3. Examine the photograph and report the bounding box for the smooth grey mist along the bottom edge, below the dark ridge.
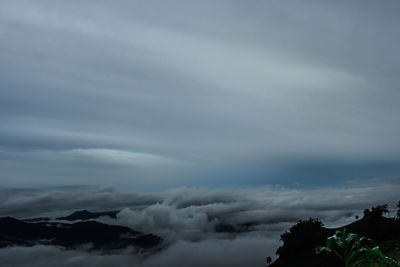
[0,240,276,267]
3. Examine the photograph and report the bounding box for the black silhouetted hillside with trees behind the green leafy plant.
[270,216,400,267]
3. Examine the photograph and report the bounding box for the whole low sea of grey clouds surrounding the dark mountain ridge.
[0,178,400,267]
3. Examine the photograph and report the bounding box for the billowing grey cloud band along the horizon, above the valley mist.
[0,178,399,224]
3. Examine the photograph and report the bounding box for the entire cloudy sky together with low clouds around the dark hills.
[0,0,400,267]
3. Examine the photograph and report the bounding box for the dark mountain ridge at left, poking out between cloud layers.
[0,217,162,251]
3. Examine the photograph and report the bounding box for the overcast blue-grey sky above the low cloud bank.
[0,0,400,191]
